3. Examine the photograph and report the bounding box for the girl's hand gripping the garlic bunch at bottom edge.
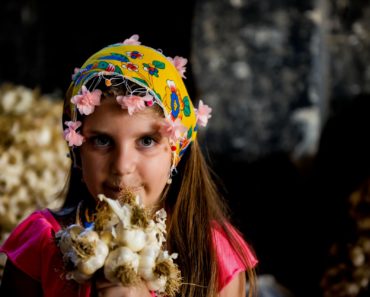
[95,279,152,297]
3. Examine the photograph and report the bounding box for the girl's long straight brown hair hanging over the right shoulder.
[165,141,256,297]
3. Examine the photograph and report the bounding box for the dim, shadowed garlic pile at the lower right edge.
[321,178,370,297]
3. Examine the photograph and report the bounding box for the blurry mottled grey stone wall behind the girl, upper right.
[192,0,370,160]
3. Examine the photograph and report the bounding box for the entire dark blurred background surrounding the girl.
[0,0,370,297]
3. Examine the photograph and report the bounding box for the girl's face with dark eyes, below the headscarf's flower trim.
[81,98,171,206]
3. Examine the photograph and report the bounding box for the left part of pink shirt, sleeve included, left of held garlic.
[0,209,90,297]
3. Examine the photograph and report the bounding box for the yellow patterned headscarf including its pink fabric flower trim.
[63,35,211,169]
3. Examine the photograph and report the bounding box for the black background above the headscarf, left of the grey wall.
[0,0,194,93]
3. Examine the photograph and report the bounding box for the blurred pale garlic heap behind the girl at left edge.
[0,84,70,279]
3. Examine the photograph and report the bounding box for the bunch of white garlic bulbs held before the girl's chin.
[56,192,181,296]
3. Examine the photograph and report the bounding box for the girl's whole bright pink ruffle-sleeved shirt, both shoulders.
[0,209,257,297]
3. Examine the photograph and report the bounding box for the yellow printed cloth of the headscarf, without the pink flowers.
[63,35,210,168]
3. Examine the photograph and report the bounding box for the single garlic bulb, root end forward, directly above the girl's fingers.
[104,247,140,286]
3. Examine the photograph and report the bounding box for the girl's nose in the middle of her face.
[111,144,137,176]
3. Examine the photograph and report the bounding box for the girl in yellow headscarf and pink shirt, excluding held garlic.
[1,35,257,297]
